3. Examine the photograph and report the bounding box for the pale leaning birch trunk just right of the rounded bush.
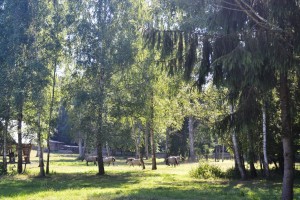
[229,104,246,180]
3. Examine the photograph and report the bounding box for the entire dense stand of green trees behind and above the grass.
[0,0,300,199]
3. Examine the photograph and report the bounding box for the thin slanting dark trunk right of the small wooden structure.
[46,60,57,174]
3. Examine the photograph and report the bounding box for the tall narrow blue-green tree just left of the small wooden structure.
[7,0,32,173]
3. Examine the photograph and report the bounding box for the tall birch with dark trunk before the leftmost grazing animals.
[68,0,136,175]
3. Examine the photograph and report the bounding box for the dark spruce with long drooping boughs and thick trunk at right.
[146,0,299,195]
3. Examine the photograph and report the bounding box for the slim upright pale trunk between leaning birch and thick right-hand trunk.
[262,102,270,178]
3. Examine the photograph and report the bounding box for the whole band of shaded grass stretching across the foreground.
[0,166,300,200]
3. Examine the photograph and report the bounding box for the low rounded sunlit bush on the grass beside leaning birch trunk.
[190,163,224,179]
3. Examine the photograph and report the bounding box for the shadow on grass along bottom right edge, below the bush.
[88,181,288,200]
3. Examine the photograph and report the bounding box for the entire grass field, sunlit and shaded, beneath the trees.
[0,151,300,200]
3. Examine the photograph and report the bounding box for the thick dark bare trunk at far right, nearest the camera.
[280,72,294,200]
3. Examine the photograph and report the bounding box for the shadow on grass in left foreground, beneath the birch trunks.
[0,172,138,199]
